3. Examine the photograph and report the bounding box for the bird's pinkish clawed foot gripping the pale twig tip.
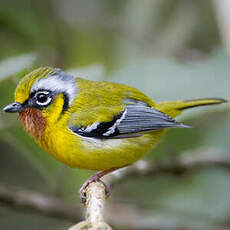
[79,175,110,203]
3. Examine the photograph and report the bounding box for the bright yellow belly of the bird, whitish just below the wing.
[39,126,164,170]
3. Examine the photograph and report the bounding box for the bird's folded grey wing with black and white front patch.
[69,102,188,139]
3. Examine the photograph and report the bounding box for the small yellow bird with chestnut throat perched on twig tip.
[3,67,226,196]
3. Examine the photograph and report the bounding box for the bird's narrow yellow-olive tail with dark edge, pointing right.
[156,98,227,118]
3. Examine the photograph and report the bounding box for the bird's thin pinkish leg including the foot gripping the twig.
[79,167,120,202]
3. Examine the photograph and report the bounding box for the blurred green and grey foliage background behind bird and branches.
[0,0,230,230]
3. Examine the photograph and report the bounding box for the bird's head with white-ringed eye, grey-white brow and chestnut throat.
[3,67,77,137]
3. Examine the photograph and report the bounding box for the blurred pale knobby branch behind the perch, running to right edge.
[104,149,230,185]
